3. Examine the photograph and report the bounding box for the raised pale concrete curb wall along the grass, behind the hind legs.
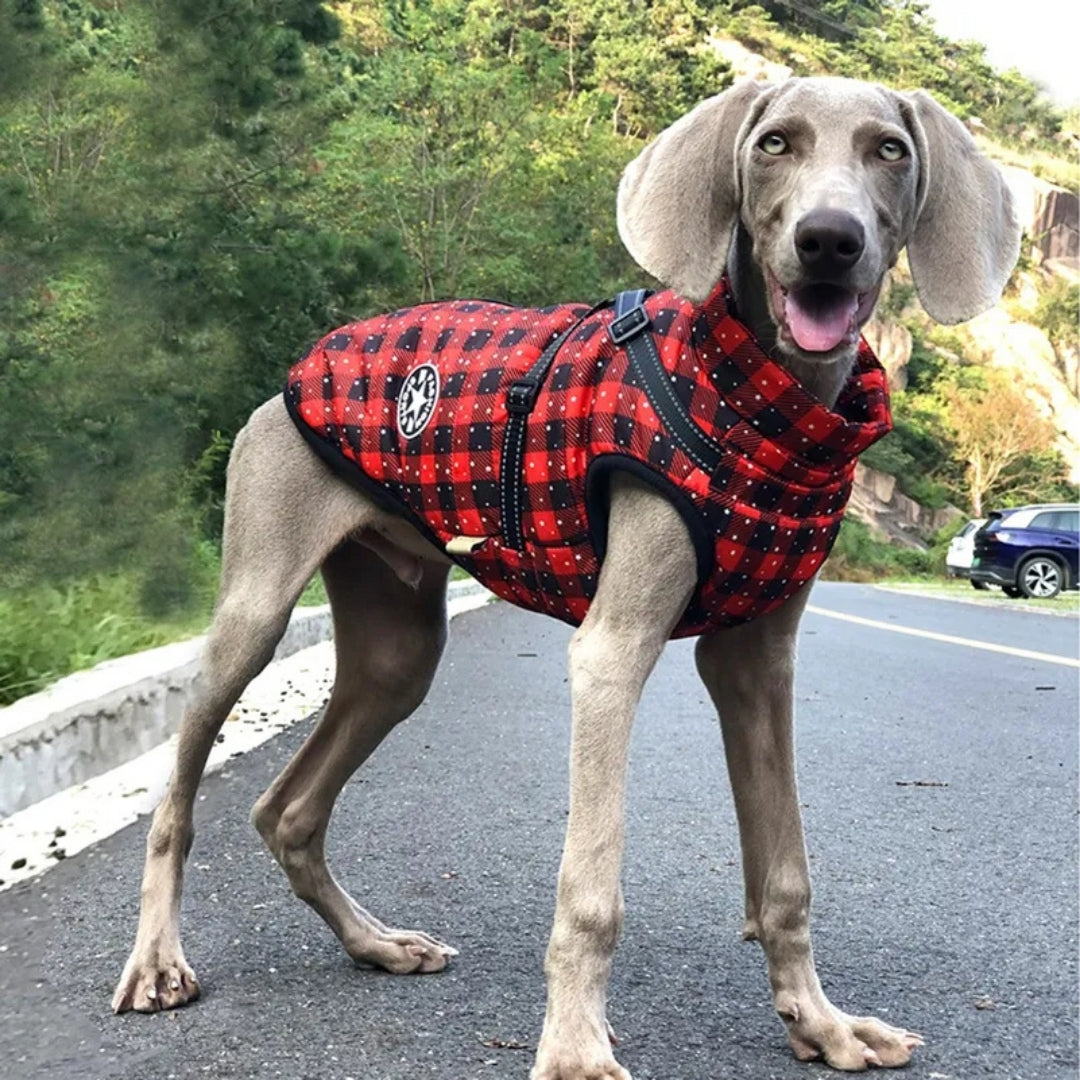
[0,581,485,818]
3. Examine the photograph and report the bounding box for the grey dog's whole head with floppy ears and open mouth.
[618,78,1020,361]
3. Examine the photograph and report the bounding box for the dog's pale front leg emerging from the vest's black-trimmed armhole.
[532,482,696,1080]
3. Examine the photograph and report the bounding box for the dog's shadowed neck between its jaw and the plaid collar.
[728,222,858,408]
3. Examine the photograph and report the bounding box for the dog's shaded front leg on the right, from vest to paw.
[697,589,922,1070]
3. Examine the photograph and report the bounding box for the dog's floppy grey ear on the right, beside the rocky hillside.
[899,90,1021,324]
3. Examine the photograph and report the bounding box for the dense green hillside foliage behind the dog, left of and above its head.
[0,0,1071,701]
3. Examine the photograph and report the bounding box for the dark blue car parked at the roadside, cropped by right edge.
[969,502,1080,598]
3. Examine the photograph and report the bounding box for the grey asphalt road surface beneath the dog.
[0,584,1078,1080]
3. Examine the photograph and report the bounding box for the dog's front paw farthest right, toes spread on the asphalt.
[777,997,922,1072]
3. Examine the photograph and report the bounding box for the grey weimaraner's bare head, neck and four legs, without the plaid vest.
[112,78,1020,1080]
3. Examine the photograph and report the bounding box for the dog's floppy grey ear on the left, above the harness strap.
[617,82,772,301]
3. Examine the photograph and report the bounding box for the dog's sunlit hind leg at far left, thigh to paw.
[112,399,379,1012]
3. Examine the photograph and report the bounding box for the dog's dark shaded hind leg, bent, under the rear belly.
[252,543,455,974]
